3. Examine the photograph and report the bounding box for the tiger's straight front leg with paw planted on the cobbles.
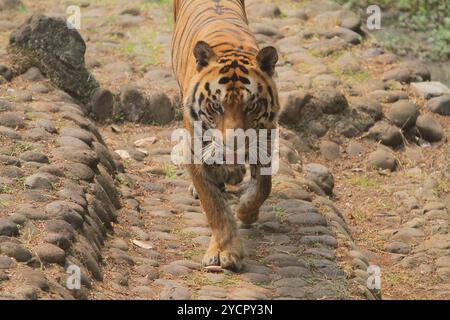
[188,165,244,271]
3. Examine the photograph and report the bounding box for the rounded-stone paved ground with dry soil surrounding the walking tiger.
[0,0,450,299]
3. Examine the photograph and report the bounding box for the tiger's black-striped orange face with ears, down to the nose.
[185,42,279,136]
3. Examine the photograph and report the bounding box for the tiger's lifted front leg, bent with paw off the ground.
[236,165,272,225]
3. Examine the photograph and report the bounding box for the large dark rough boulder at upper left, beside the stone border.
[8,14,99,104]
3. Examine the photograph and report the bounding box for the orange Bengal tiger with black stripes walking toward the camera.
[172,0,279,271]
